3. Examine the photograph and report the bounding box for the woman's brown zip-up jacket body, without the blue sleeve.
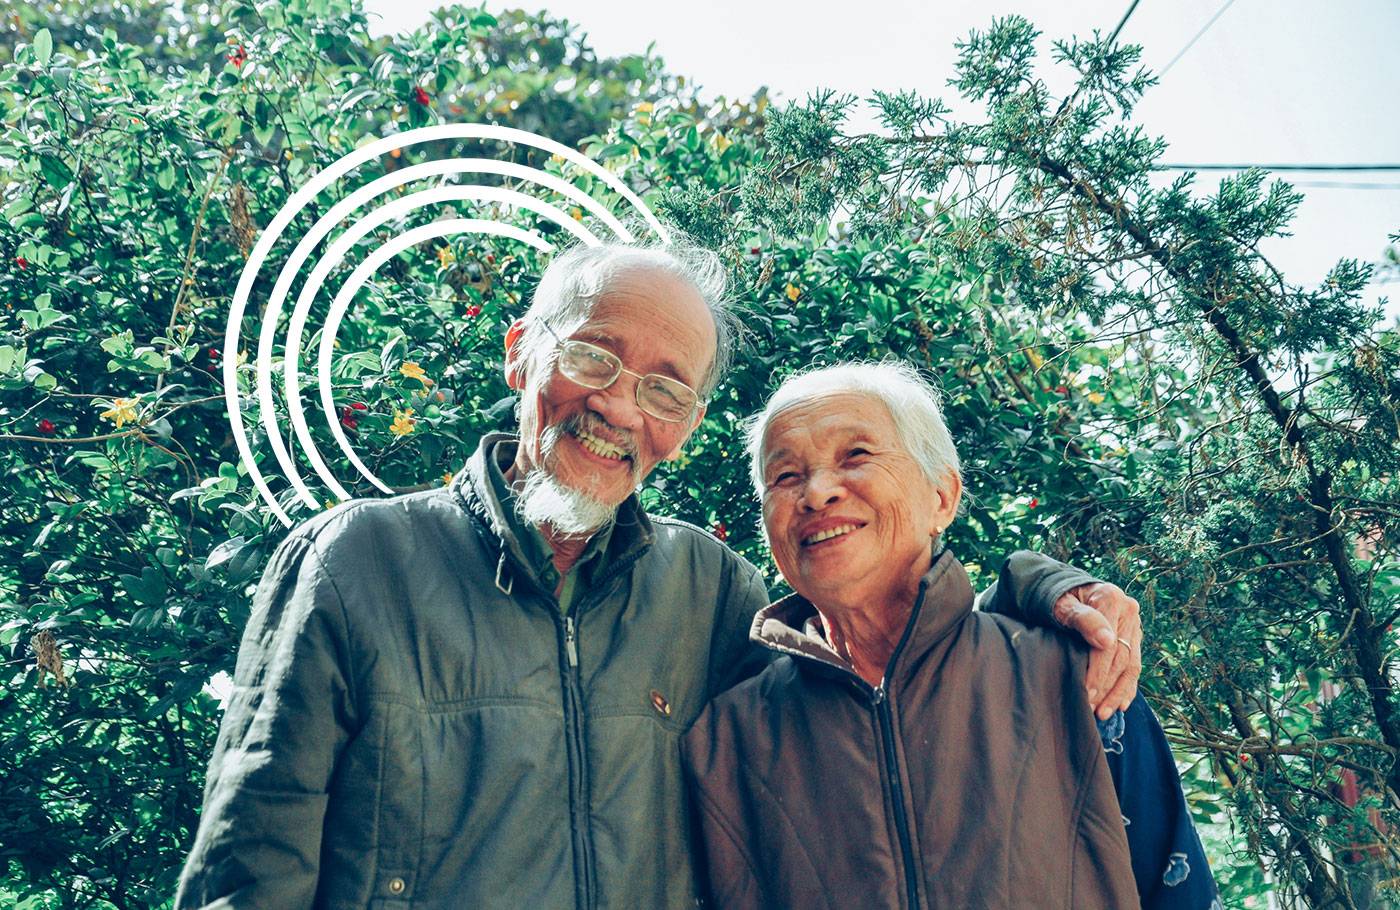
[685,552,1138,910]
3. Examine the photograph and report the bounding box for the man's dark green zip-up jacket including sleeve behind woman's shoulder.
[176,434,1089,910]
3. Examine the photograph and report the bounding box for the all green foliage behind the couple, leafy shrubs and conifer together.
[0,0,1400,907]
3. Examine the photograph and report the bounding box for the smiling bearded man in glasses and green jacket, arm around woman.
[176,238,1138,910]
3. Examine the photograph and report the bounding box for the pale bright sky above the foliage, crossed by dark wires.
[365,0,1400,315]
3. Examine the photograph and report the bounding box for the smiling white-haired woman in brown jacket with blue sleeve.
[685,364,1215,910]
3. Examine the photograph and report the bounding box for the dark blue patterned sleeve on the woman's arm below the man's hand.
[1099,694,1221,910]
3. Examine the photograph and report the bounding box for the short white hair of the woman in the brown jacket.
[745,360,962,498]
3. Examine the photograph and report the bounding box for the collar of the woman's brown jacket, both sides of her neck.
[749,550,973,685]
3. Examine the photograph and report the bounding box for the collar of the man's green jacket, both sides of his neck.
[452,433,655,584]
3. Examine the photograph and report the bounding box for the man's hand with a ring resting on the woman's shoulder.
[1054,581,1142,720]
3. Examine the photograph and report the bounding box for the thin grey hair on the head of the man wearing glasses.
[519,239,738,400]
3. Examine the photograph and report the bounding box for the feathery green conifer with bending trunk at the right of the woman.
[716,18,1400,907]
